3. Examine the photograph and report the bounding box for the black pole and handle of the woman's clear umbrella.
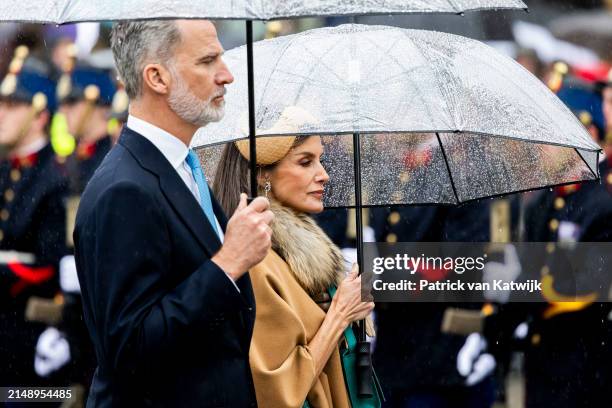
[353,133,373,397]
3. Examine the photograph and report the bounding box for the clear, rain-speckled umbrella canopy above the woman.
[193,25,600,207]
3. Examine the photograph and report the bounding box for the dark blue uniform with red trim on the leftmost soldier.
[0,144,68,385]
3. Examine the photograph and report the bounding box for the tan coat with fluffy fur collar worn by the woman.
[249,204,350,408]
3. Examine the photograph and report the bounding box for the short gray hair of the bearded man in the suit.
[111,20,181,99]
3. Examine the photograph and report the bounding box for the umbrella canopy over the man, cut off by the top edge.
[0,0,527,24]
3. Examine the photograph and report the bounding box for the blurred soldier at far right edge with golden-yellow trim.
[525,75,612,407]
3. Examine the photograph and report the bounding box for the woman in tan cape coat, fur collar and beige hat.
[214,111,374,408]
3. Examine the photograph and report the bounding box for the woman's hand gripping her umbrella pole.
[330,264,374,327]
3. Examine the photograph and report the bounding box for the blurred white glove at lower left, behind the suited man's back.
[34,327,70,377]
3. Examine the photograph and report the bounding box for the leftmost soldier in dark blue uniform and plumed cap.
[0,46,68,386]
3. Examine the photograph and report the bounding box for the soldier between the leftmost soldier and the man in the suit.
[32,67,121,400]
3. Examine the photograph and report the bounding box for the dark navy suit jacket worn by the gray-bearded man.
[74,128,256,408]
